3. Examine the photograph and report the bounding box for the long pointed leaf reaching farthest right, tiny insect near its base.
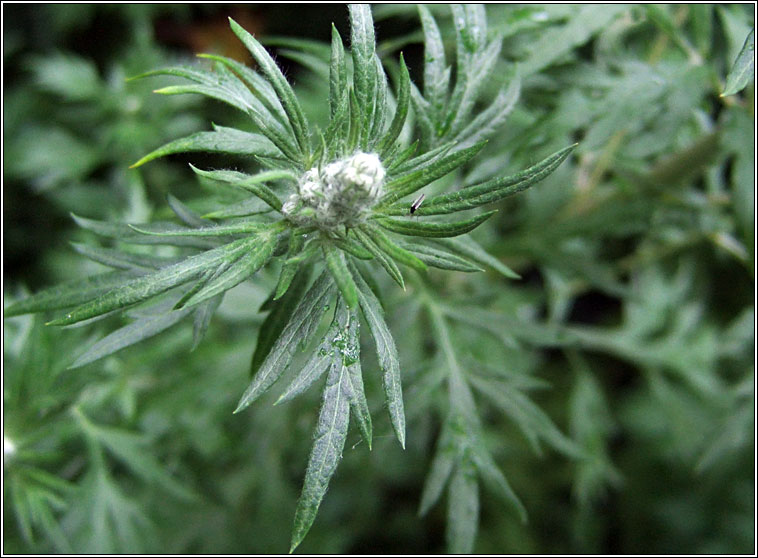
[394,144,577,215]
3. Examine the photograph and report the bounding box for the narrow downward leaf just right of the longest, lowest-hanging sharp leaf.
[353,268,405,448]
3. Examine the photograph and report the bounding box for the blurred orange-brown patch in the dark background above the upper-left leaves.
[155,6,266,63]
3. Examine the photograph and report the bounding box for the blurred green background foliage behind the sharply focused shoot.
[3,4,755,554]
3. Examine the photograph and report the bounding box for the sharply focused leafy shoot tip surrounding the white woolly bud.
[6,5,574,549]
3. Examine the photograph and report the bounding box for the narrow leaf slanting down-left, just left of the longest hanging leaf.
[234,271,334,413]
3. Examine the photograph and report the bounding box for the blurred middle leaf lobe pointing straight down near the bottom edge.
[445,458,479,554]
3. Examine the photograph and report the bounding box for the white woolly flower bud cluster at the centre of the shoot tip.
[282,152,385,229]
